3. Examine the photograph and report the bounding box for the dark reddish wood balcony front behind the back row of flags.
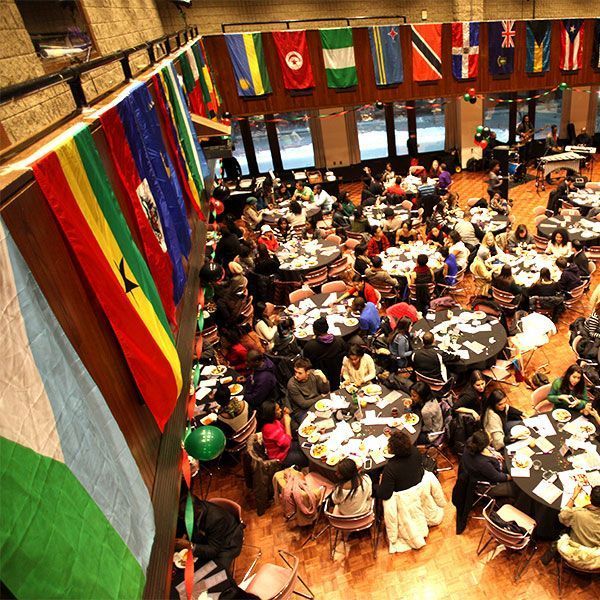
[204,19,600,116]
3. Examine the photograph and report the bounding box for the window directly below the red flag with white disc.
[275,112,315,169]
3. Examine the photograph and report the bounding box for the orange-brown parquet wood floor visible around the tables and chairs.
[204,164,600,600]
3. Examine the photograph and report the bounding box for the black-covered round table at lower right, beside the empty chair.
[504,411,600,539]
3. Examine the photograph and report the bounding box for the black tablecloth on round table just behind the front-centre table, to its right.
[412,310,508,371]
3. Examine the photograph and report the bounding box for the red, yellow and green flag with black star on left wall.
[33,125,182,431]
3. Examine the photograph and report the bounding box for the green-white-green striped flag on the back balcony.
[320,27,358,89]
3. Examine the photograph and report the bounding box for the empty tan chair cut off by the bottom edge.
[240,550,315,600]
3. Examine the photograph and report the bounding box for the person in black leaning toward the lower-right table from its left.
[460,431,518,498]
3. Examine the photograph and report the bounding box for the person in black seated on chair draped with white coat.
[373,429,425,500]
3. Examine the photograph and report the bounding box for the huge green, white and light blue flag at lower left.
[0,220,155,598]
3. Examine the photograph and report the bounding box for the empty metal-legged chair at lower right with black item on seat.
[477,500,537,582]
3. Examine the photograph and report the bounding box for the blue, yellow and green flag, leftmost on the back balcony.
[225,33,271,96]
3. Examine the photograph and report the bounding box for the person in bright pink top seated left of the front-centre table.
[261,402,308,467]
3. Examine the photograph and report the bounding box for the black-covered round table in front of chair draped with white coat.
[298,384,421,478]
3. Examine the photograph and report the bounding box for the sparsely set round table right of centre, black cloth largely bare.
[412,310,508,371]
